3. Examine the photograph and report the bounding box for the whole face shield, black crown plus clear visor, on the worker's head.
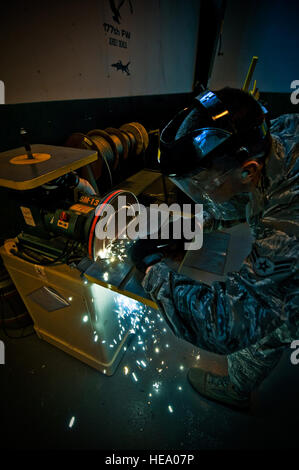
[160,91,267,218]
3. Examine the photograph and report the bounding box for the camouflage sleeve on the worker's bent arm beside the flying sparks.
[143,233,299,354]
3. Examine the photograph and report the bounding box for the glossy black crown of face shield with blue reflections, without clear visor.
[159,90,269,176]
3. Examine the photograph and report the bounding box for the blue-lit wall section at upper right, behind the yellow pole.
[209,0,299,92]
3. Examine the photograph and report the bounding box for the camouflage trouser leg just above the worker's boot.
[227,321,299,393]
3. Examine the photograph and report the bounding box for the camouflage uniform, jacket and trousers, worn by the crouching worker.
[143,114,299,392]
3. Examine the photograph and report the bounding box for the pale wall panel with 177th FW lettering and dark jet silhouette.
[0,0,200,104]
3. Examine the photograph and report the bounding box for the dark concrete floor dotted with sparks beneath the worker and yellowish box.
[0,226,299,450]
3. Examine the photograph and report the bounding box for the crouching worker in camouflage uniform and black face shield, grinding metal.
[130,88,299,408]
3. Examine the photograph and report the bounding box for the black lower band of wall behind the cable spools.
[0,93,191,152]
